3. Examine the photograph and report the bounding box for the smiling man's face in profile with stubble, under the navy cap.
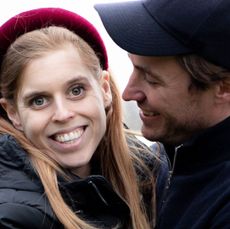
[123,54,217,144]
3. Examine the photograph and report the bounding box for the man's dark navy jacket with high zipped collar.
[157,117,230,229]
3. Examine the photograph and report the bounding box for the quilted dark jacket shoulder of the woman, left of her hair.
[0,135,61,229]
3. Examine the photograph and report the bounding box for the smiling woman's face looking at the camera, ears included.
[3,47,111,176]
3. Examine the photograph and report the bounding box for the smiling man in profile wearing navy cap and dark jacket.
[95,0,230,229]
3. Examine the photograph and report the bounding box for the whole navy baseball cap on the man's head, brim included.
[95,0,230,69]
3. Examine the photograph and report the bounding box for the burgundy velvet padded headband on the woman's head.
[0,8,108,69]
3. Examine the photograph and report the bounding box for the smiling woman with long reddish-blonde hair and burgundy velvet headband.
[0,8,164,229]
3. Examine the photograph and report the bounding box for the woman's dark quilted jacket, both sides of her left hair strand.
[0,135,164,229]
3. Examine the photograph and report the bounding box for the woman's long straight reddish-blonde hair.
[0,26,157,229]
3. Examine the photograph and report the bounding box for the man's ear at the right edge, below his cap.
[215,79,230,103]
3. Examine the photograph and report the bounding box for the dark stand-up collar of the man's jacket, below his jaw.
[165,117,230,172]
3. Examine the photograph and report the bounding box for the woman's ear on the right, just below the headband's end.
[101,70,112,108]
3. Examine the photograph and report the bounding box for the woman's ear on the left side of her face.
[0,98,23,131]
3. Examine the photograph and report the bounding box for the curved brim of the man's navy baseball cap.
[94,1,192,56]
